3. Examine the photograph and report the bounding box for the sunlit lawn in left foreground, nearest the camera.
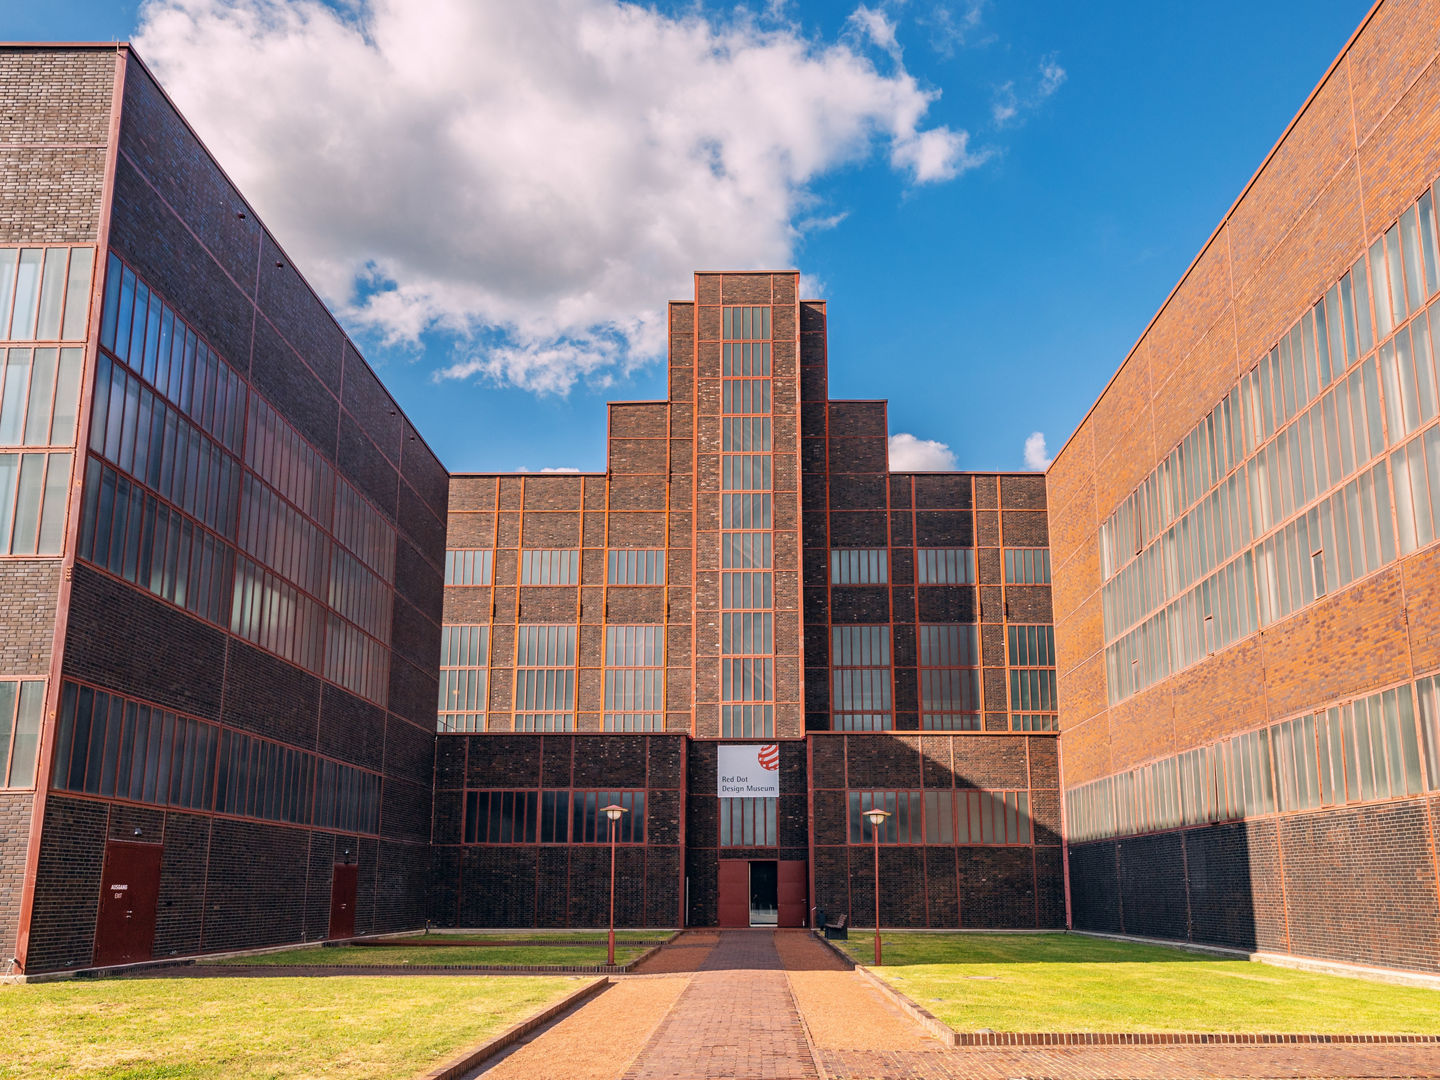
[0,975,588,1080]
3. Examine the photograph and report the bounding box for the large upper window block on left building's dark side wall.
[81,253,396,704]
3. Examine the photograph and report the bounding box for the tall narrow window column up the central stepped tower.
[720,307,775,739]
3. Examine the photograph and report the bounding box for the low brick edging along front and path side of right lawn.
[815,935,1440,1047]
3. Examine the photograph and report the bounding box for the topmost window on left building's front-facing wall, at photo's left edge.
[0,248,95,341]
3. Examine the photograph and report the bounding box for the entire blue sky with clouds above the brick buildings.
[16,0,1368,471]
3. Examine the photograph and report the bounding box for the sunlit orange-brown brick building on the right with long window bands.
[1047,0,1440,972]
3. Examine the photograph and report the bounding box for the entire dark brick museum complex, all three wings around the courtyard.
[8,0,1440,990]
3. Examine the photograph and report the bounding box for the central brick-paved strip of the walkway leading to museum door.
[625,930,819,1080]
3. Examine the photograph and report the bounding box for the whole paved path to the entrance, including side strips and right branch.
[484,930,1440,1080]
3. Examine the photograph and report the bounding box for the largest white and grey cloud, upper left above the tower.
[135,0,985,393]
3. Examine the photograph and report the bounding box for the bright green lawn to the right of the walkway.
[841,930,1440,1034]
